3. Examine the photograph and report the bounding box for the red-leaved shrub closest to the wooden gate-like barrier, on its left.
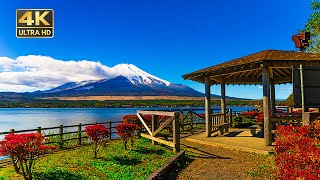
[116,124,140,149]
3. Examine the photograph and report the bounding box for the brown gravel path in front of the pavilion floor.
[177,139,274,180]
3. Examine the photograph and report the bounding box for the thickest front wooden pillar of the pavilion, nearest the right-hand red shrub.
[262,65,271,146]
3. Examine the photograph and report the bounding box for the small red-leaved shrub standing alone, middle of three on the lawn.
[85,124,110,158]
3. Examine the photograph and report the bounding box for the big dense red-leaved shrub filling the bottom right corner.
[275,126,320,179]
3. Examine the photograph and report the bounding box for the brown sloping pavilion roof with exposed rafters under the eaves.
[182,50,320,84]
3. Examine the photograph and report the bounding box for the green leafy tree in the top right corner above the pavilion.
[300,0,320,53]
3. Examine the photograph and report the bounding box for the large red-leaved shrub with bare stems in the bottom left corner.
[0,133,55,179]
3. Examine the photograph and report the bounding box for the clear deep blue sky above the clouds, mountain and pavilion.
[0,0,311,98]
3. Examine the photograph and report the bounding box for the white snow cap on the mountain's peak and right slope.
[110,64,171,86]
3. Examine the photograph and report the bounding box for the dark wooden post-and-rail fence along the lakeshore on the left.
[0,121,122,149]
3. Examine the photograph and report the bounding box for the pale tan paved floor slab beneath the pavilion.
[185,129,274,154]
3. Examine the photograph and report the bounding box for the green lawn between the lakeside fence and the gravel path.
[0,138,174,180]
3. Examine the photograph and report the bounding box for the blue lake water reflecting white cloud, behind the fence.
[0,107,254,160]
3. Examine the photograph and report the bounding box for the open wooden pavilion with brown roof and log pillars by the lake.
[182,50,320,146]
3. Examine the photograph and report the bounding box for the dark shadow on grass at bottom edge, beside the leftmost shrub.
[35,169,85,180]
